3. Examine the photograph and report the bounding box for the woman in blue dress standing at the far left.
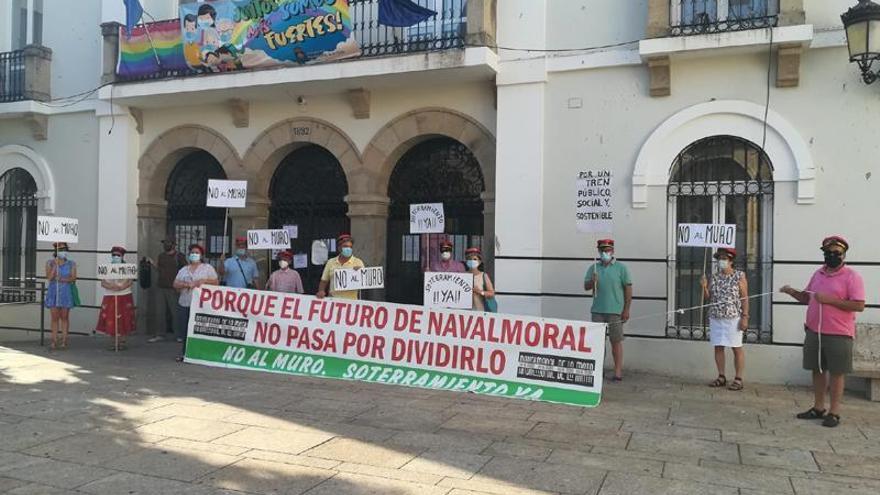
[46,242,76,350]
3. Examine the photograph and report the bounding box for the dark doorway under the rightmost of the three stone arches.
[385,137,486,304]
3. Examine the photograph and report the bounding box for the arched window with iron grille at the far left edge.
[0,168,38,302]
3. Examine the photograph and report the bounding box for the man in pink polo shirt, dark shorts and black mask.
[780,235,865,428]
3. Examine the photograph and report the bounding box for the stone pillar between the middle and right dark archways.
[345,194,391,300]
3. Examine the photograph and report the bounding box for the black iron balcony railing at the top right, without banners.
[669,0,779,36]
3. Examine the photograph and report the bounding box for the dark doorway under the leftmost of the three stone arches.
[165,150,232,268]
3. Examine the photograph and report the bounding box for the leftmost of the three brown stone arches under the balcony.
[138,124,244,205]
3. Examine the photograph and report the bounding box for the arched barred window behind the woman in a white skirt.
[667,136,774,343]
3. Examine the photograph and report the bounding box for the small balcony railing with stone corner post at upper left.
[0,45,52,103]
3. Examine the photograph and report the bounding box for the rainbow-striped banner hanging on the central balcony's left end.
[116,19,190,79]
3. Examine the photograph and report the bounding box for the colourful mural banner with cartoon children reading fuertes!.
[180,0,361,72]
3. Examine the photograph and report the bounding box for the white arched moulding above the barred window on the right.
[632,100,816,208]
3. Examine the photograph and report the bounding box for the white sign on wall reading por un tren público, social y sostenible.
[575,170,614,233]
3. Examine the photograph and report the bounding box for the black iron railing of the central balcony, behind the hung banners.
[116,0,468,81]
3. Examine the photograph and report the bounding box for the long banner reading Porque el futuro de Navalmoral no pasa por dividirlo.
[186,286,605,406]
